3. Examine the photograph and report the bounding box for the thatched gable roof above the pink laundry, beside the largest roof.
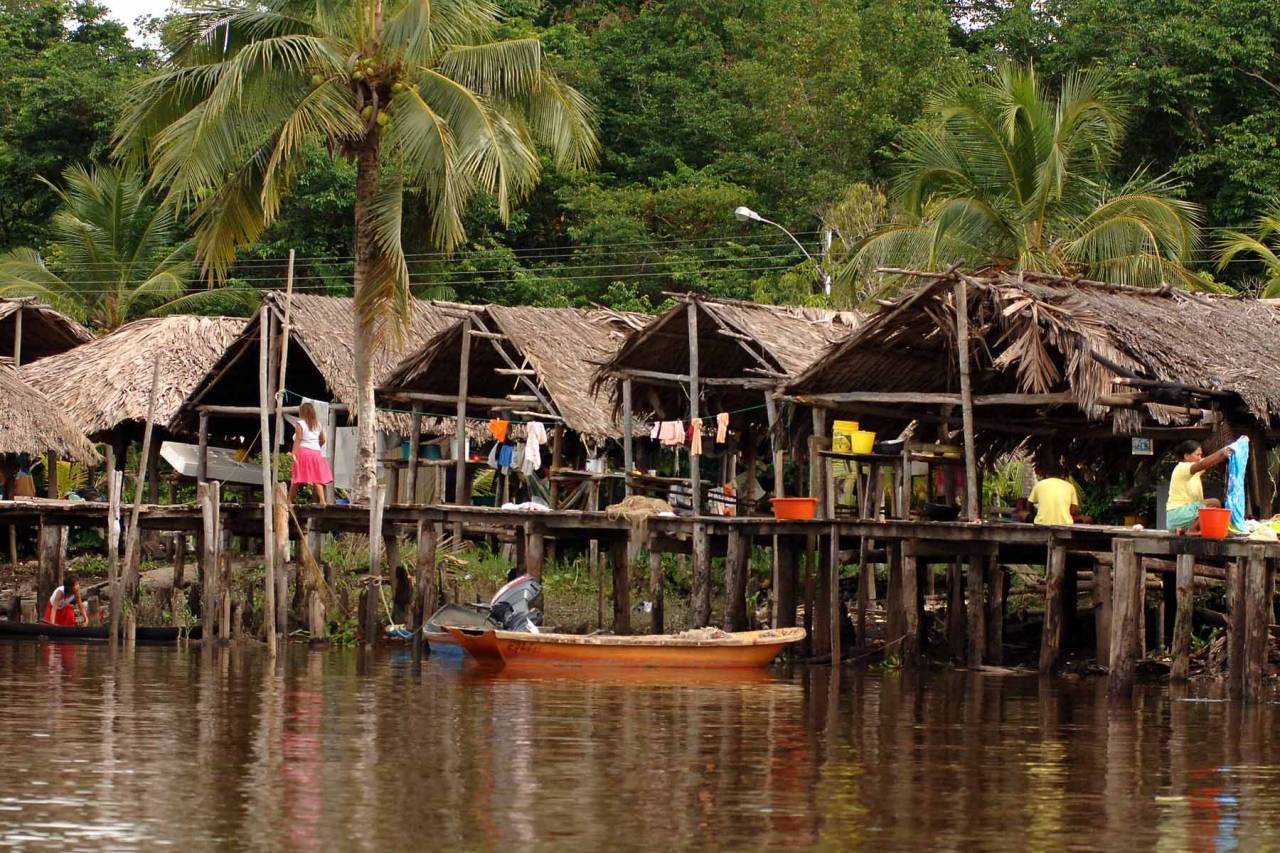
[598,293,861,418]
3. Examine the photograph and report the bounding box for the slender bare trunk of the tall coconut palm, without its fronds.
[352,132,379,503]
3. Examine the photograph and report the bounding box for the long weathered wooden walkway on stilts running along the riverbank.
[0,500,1280,701]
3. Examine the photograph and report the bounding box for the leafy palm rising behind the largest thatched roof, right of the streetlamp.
[842,65,1204,297]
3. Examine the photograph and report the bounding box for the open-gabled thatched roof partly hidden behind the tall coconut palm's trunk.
[177,292,461,434]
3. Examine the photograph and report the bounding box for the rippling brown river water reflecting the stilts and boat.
[0,642,1280,852]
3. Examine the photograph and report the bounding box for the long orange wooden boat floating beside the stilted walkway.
[447,626,804,670]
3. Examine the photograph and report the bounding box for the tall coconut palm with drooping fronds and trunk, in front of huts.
[116,0,596,498]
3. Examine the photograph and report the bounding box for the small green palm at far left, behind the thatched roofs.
[0,165,217,329]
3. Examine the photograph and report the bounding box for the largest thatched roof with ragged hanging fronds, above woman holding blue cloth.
[788,273,1280,433]
